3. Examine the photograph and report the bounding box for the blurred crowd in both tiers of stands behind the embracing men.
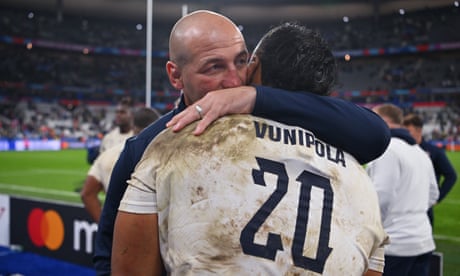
[0,5,460,140]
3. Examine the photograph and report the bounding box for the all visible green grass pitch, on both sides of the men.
[0,150,460,276]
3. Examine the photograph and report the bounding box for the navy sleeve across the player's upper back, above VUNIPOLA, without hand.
[253,86,391,164]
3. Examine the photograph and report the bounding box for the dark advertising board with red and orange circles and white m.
[10,197,97,267]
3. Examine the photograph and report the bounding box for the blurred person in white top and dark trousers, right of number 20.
[367,104,439,276]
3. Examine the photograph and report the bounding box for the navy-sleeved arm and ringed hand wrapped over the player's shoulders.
[167,86,391,164]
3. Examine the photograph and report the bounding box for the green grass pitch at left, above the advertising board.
[0,150,89,203]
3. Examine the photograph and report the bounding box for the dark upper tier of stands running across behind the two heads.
[0,4,460,50]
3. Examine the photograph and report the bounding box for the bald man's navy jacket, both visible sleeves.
[93,86,390,275]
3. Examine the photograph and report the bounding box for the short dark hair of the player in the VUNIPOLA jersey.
[256,22,337,95]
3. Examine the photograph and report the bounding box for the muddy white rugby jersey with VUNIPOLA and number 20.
[119,115,386,275]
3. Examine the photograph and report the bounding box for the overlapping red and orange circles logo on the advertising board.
[27,208,64,250]
